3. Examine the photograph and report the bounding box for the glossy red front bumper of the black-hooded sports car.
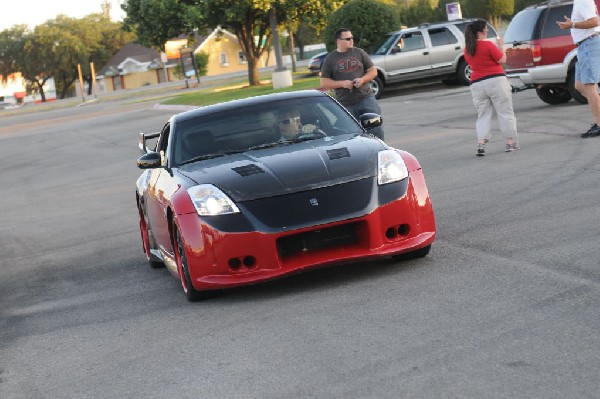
[178,170,436,290]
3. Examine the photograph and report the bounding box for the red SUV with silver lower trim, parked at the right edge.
[504,0,600,104]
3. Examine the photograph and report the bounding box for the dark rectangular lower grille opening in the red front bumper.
[277,223,359,258]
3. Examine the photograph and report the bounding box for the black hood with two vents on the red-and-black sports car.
[179,136,385,201]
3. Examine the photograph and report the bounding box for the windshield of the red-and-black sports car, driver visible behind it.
[172,96,364,165]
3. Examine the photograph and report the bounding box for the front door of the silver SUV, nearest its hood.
[385,31,431,83]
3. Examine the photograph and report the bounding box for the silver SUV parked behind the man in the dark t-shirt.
[370,18,498,98]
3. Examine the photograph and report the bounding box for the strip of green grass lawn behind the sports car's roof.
[162,72,320,106]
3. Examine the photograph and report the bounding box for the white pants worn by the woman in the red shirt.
[470,76,519,145]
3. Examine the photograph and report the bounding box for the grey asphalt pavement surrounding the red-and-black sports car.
[0,85,600,399]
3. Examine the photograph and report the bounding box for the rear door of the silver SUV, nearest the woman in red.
[427,27,463,76]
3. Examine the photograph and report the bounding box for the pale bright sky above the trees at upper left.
[0,0,125,31]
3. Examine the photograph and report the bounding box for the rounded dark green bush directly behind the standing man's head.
[325,0,400,51]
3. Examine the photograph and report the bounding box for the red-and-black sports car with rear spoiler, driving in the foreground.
[136,90,436,301]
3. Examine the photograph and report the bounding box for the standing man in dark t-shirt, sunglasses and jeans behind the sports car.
[321,28,383,140]
